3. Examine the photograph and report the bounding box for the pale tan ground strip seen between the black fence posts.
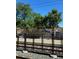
[16,38,63,45]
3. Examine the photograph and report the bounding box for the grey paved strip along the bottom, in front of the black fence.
[16,51,63,59]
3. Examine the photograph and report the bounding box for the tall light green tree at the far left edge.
[16,3,32,28]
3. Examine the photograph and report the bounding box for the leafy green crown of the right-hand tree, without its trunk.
[48,9,62,29]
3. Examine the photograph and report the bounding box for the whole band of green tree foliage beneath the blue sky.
[16,3,62,29]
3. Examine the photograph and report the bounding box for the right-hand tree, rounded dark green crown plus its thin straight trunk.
[47,9,62,52]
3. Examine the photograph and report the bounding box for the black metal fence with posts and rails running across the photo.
[16,32,63,57]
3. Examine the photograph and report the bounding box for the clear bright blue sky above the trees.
[16,0,63,27]
